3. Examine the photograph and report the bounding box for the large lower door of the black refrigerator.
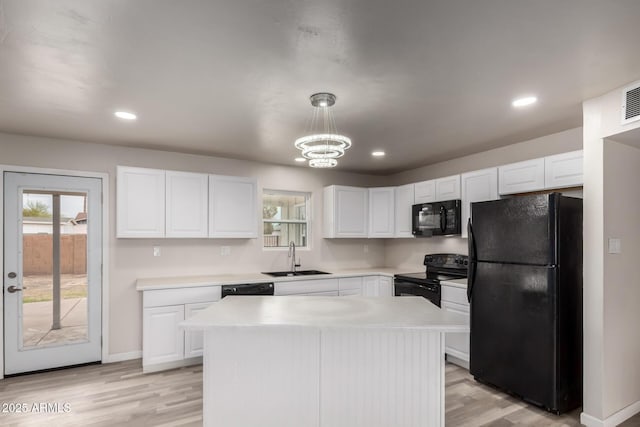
[470,262,557,410]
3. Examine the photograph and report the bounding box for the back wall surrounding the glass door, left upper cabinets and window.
[0,134,385,354]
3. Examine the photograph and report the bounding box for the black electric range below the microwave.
[393,254,469,307]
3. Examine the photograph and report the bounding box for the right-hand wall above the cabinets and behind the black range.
[384,128,582,272]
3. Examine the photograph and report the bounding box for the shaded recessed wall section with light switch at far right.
[603,139,640,416]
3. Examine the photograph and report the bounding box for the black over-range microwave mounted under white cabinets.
[412,200,462,237]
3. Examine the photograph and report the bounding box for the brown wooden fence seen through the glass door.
[22,234,87,276]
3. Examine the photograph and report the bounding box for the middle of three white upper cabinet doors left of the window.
[165,171,209,237]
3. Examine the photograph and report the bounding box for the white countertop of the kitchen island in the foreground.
[181,295,469,332]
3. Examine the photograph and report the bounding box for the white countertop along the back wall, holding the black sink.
[136,267,400,291]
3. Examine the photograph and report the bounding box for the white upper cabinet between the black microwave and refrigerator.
[460,168,499,237]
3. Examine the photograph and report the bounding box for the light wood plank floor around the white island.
[0,360,640,427]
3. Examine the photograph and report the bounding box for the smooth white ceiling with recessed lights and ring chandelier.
[0,0,640,174]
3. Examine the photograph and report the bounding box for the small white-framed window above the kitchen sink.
[262,190,311,248]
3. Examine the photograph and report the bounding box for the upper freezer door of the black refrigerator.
[470,194,559,265]
